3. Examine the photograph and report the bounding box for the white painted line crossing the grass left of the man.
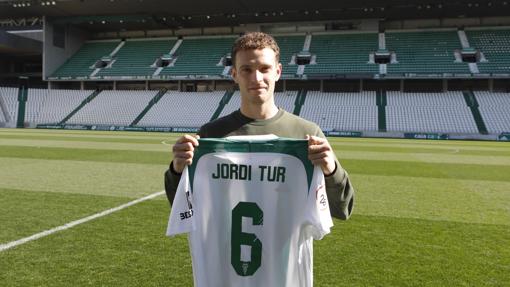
[0,190,165,252]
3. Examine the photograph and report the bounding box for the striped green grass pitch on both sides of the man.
[0,129,510,287]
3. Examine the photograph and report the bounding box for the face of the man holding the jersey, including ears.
[232,48,282,104]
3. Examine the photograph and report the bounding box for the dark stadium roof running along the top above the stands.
[0,0,510,31]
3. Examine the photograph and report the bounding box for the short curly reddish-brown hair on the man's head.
[231,32,280,67]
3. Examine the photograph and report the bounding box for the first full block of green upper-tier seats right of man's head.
[305,33,379,75]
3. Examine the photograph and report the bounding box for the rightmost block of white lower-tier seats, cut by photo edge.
[474,91,510,133]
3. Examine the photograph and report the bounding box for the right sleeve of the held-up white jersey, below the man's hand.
[306,167,333,240]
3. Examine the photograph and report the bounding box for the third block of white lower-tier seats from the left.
[67,91,158,126]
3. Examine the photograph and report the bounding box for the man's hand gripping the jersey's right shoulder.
[306,135,336,176]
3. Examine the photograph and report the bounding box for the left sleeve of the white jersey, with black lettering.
[166,167,195,236]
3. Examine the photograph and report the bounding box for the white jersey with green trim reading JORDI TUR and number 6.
[167,137,333,287]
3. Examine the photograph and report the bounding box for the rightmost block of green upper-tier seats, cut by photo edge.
[466,29,510,74]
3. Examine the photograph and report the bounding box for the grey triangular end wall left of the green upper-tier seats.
[43,17,90,79]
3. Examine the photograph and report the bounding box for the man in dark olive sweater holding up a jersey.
[165,32,354,220]
